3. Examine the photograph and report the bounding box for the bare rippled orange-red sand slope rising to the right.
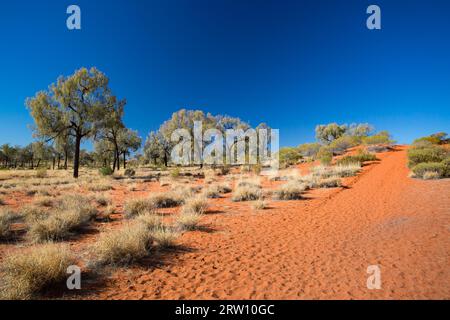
[89,148,450,299]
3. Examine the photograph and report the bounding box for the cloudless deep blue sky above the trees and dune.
[0,0,450,145]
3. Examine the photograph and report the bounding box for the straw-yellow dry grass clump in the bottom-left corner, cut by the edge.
[1,244,75,299]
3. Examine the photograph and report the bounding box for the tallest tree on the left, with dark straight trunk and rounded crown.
[26,68,114,178]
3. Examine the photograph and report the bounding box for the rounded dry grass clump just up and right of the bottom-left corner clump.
[92,223,153,265]
